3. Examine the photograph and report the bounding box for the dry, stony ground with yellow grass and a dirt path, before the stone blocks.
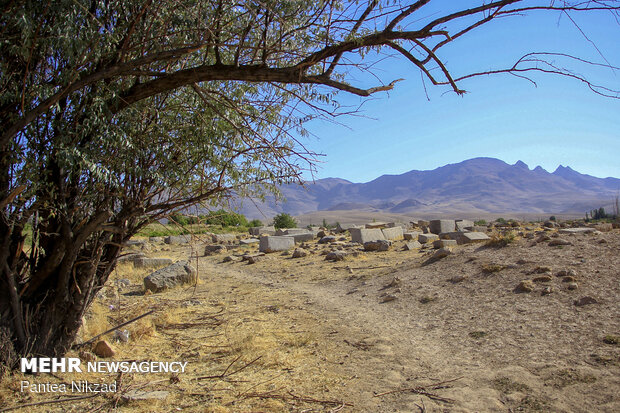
[0,220,620,412]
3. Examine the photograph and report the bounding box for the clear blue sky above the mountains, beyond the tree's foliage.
[304,2,620,182]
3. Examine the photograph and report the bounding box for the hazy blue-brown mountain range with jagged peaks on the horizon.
[234,158,620,218]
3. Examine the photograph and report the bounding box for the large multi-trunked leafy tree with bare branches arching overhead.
[0,0,619,364]
